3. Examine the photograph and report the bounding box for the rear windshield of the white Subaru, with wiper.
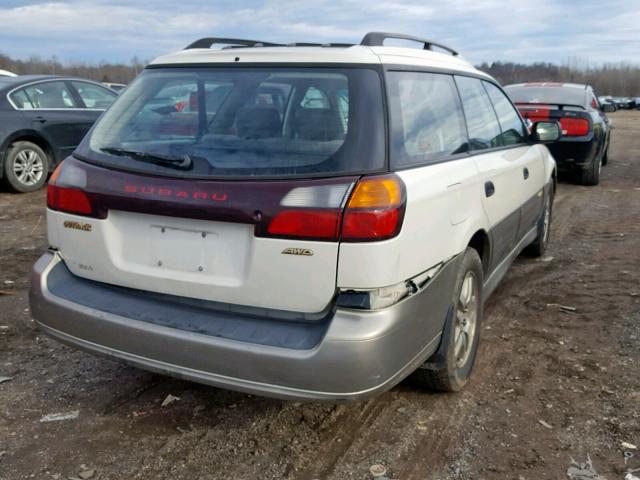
[77,67,385,178]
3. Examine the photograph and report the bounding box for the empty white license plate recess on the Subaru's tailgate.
[150,225,218,275]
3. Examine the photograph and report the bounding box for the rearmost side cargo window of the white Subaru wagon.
[387,72,467,166]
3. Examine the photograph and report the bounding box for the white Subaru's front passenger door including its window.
[482,82,545,241]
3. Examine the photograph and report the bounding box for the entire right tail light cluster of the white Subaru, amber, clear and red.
[266,175,405,242]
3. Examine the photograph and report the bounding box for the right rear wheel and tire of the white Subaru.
[411,247,484,392]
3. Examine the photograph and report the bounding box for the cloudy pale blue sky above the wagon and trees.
[0,0,640,66]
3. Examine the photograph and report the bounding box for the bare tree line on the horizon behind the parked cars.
[0,53,640,96]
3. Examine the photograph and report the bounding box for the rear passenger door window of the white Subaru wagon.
[456,76,502,150]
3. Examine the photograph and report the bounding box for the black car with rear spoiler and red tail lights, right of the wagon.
[505,82,613,185]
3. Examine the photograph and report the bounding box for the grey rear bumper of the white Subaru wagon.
[30,252,457,400]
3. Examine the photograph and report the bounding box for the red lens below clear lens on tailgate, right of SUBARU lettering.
[268,209,340,240]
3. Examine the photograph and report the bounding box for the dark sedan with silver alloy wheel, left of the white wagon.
[0,75,117,192]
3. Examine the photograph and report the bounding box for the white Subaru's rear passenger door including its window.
[456,76,525,268]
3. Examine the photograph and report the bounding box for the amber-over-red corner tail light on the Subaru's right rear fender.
[341,175,405,242]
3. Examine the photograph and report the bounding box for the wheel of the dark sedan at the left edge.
[4,142,49,193]
